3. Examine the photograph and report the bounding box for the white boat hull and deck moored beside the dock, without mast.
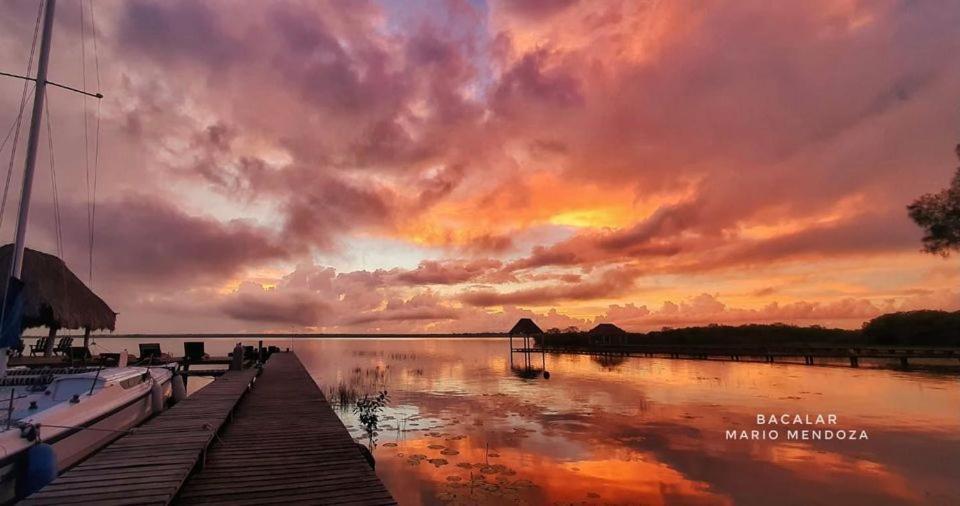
[0,367,173,504]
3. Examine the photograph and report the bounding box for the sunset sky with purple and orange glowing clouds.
[0,0,960,332]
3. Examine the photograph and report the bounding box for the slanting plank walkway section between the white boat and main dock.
[20,369,258,505]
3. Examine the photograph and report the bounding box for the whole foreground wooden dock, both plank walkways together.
[21,353,396,505]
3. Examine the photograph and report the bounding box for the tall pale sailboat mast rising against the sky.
[10,0,57,279]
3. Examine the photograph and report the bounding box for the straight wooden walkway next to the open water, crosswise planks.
[176,353,396,505]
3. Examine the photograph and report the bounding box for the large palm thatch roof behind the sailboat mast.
[0,244,117,330]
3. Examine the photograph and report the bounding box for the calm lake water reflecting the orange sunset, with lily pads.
[92,339,960,505]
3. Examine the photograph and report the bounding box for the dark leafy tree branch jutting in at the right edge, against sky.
[907,144,960,256]
